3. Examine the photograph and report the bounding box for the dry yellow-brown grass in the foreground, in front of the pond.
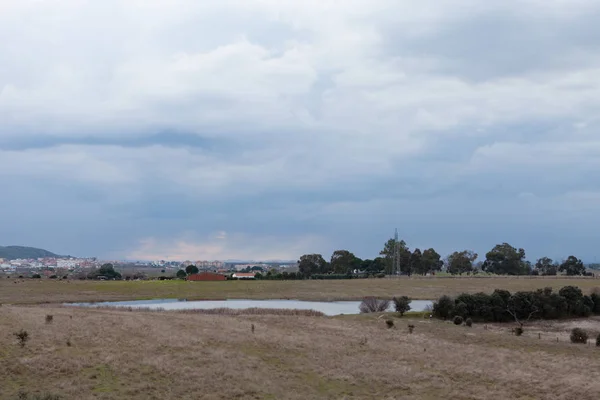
[0,306,600,400]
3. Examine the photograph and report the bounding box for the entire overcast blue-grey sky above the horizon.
[0,0,600,262]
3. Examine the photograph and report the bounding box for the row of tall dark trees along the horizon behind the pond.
[298,239,586,278]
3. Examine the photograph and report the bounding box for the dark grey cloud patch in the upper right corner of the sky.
[385,4,600,82]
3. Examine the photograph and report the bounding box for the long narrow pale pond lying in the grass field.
[68,299,433,316]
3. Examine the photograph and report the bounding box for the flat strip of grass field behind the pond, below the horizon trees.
[0,277,600,304]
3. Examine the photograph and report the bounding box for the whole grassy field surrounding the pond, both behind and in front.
[0,278,600,400]
